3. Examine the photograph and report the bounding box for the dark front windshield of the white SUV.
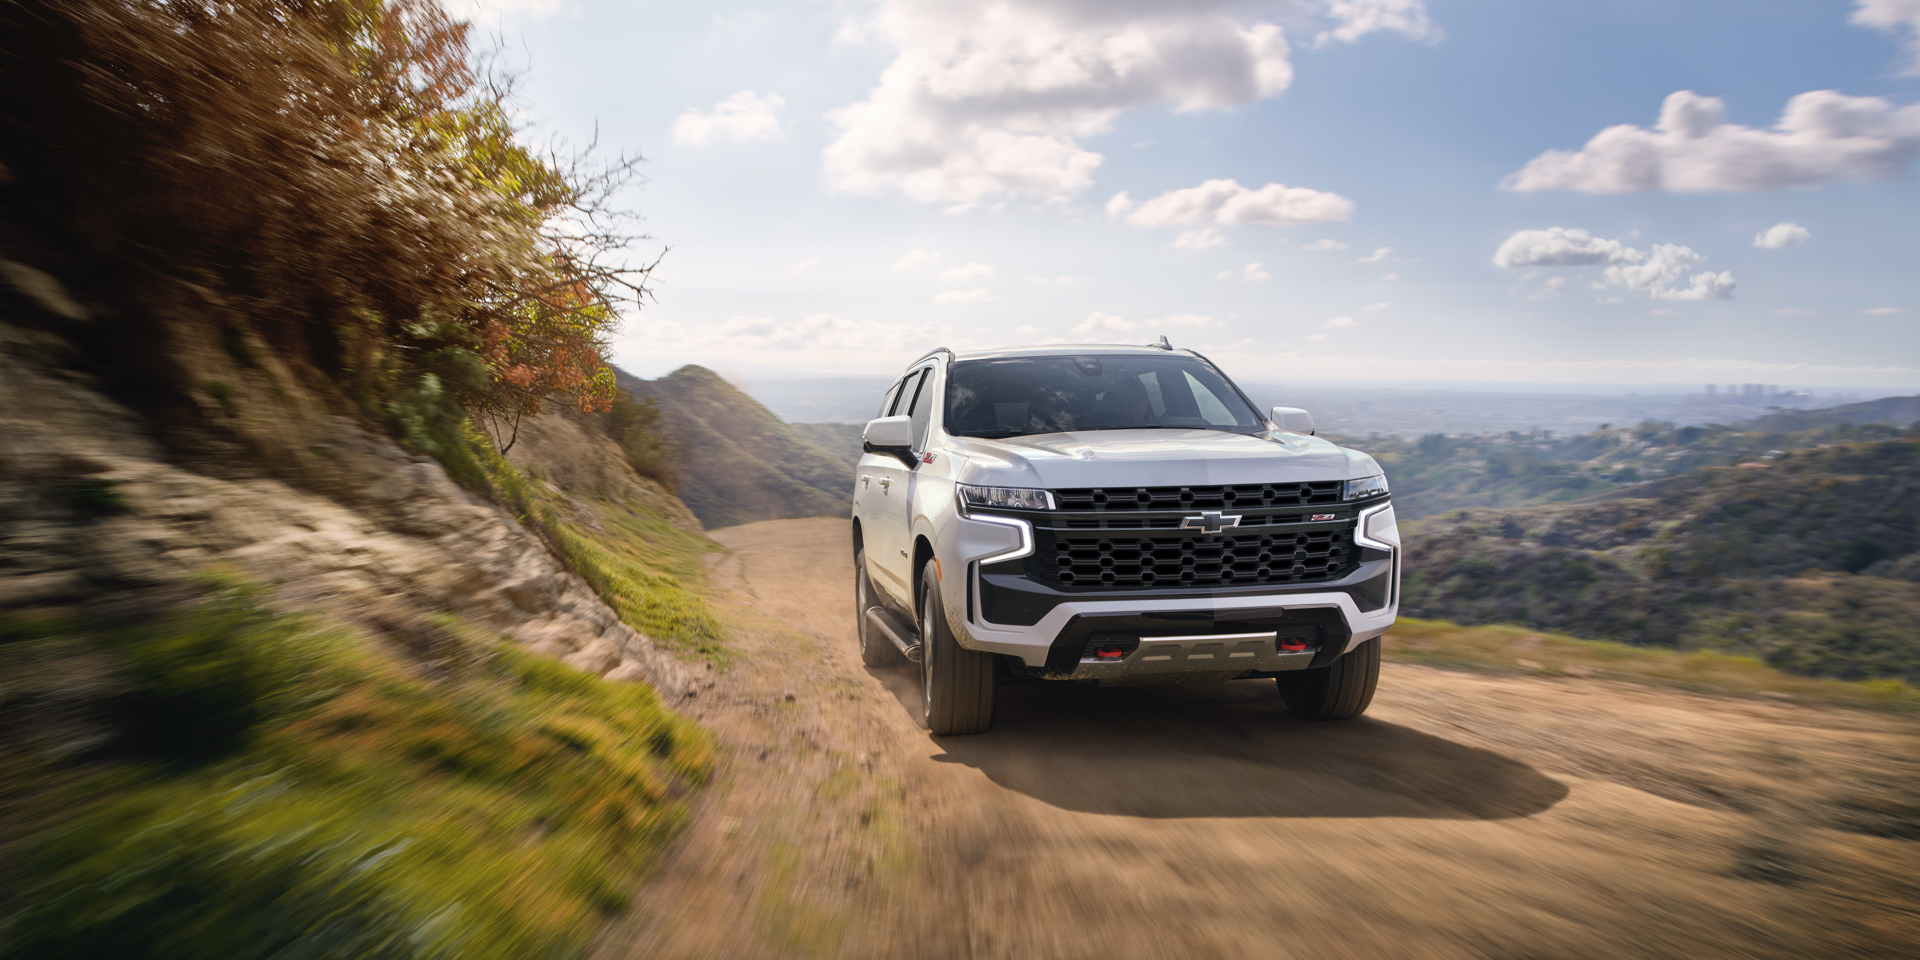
[947,355,1267,438]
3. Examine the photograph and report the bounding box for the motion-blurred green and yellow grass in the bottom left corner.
[0,584,712,960]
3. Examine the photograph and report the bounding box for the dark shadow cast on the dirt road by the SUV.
[874,668,1569,820]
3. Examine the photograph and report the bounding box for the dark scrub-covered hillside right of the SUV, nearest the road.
[1404,442,1920,678]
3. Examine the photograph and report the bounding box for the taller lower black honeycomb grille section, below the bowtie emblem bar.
[1029,528,1356,589]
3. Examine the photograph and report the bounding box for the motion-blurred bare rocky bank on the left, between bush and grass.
[0,261,697,697]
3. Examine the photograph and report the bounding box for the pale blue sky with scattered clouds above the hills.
[447,0,1920,392]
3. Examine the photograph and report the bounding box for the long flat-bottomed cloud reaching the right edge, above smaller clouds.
[1501,90,1920,194]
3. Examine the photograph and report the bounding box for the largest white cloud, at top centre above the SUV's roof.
[826,0,1294,204]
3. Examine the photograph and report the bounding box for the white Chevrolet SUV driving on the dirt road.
[852,338,1400,733]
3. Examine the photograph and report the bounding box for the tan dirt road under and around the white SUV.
[599,520,1920,960]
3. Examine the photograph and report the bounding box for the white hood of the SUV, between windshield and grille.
[950,430,1380,488]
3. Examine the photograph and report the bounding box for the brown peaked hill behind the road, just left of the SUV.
[614,365,852,530]
